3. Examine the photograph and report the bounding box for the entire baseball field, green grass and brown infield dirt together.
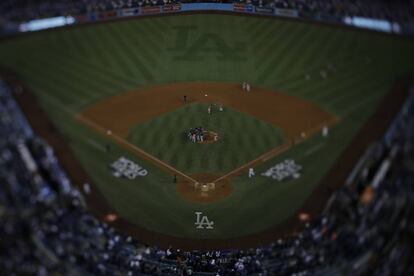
[0,14,414,248]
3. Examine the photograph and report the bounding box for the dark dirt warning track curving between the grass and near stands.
[3,69,413,250]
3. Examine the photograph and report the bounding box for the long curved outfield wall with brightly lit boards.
[4,3,414,36]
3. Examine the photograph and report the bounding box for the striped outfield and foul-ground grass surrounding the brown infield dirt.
[0,14,414,238]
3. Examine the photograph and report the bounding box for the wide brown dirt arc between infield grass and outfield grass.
[81,82,334,139]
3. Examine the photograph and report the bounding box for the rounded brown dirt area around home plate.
[177,173,232,203]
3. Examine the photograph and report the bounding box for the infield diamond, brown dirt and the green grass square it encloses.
[78,83,338,202]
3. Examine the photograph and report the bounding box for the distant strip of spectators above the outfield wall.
[0,0,414,22]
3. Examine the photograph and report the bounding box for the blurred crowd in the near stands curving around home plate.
[0,76,414,275]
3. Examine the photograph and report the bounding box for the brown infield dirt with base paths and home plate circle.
[78,82,338,203]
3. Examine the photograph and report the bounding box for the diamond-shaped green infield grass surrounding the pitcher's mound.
[128,103,283,173]
